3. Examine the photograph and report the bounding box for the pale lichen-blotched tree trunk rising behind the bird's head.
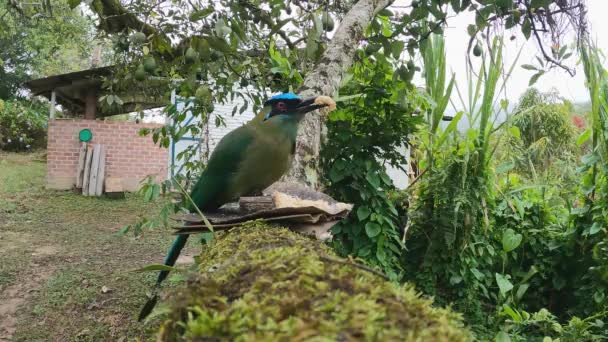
[284,0,393,188]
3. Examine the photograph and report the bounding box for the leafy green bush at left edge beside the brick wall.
[0,100,47,151]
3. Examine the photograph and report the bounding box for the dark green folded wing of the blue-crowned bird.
[189,125,255,211]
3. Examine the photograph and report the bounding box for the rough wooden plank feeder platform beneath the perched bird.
[173,182,353,240]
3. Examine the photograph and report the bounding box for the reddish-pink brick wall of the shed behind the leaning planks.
[47,119,168,191]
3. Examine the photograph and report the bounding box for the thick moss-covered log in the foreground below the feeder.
[159,223,470,341]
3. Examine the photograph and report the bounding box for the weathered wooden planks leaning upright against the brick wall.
[76,143,106,196]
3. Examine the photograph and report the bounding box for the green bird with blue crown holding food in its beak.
[139,93,336,320]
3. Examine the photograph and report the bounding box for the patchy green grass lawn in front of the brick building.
[0,152,197,341]
